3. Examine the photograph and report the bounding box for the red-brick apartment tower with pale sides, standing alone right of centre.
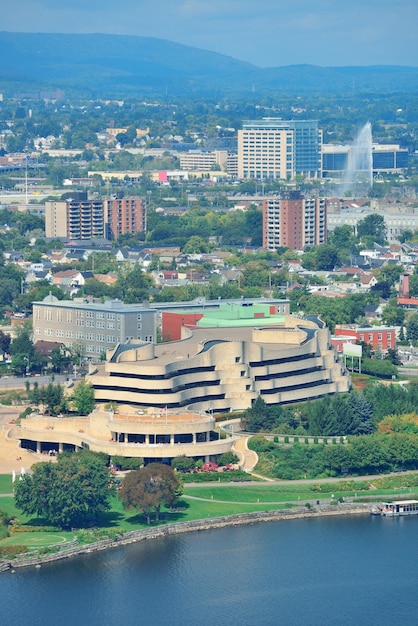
[263,192,327,251]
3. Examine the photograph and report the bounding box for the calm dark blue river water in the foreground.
[0,516,418,626]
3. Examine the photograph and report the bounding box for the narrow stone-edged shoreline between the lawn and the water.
[0,503,371,573]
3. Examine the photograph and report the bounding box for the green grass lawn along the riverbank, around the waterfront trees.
[0,475,418,549]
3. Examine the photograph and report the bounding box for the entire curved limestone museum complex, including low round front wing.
[9,303,350,462]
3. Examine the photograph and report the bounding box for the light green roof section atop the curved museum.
[198,302,286,328]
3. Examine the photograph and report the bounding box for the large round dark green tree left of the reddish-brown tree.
[15,451,112,528]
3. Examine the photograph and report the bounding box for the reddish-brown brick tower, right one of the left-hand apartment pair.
[104,194,147,239]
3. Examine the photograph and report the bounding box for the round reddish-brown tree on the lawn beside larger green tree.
[119,463,181,524]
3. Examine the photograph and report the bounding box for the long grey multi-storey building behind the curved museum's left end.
[33,295,157,361]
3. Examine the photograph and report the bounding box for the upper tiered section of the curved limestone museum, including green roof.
[87,304,350,412]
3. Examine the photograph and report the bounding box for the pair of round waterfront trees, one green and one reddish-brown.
[15,451,182,528]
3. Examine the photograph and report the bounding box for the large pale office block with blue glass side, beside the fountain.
[238,118,322,180]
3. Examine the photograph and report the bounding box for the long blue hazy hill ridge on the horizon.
[0,32,418,97]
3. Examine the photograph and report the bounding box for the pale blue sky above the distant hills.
[0,0,418,67]
